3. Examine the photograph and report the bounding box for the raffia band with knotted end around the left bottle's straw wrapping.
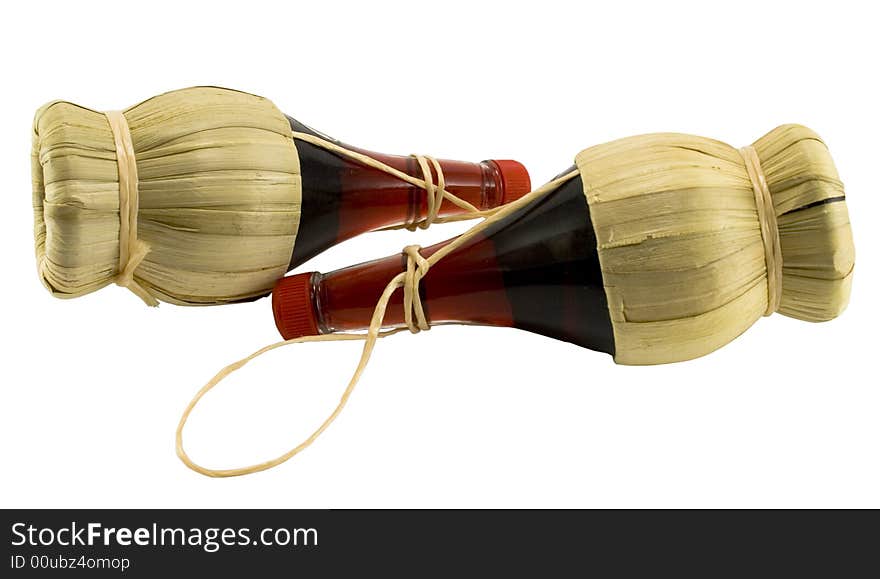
[104,111,159,307]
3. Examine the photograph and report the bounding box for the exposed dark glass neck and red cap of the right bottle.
[272,170,614,354]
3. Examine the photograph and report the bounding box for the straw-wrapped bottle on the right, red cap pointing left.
[274,125,854,364]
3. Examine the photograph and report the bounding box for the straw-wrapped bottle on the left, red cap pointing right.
[32,87,530,305]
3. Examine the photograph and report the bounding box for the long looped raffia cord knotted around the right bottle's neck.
[175,170,578,477]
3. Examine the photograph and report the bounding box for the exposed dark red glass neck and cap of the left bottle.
[288,117,529,269]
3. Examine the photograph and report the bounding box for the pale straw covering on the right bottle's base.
[577,125,854,364]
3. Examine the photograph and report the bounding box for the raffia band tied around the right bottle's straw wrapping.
[739,146,782,316]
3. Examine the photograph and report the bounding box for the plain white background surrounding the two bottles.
[0,0,880,507]
